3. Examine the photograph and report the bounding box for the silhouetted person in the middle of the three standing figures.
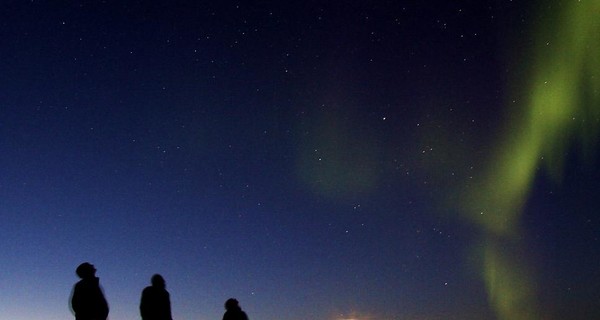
[140,274,173,320]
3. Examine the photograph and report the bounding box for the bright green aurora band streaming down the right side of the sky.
[462,0,600,320]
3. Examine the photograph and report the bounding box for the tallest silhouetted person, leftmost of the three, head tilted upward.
[71,262,108,320]
